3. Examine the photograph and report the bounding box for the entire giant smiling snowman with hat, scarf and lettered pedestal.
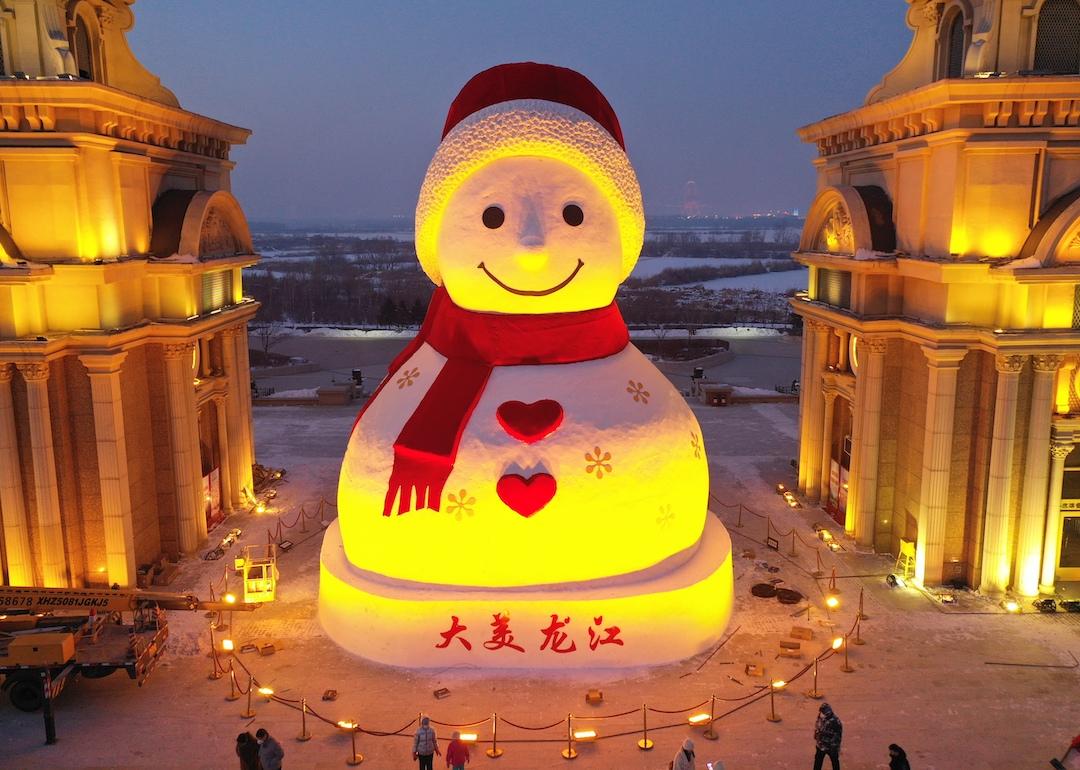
[320,63,732,668]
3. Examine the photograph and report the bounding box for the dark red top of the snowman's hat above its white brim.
[443,62,626,150]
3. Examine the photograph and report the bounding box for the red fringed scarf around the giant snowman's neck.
[353,286,630,516]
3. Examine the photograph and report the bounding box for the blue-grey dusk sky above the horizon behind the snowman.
[129,0,910,220]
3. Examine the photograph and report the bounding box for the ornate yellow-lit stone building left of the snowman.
[0,0,257,585]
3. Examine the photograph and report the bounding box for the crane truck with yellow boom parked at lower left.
[0,585,259,743]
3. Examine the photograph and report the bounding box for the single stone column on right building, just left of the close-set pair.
[915,348,967,585]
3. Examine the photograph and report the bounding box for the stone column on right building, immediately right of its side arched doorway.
[849,337,888,545]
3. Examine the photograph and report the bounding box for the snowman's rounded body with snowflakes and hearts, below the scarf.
[338,345,708,586]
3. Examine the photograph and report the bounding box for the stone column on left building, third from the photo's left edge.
[79,352,135,586]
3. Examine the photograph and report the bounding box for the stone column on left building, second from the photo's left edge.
[16,363,68,587]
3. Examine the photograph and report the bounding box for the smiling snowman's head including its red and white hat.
[416,64,645,313]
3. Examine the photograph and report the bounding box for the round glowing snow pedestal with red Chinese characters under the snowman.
[319,515,734,668]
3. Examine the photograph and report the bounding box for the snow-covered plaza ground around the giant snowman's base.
[0,340,1080,770]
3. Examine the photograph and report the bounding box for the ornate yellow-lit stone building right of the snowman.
[793,0,1080,596]
